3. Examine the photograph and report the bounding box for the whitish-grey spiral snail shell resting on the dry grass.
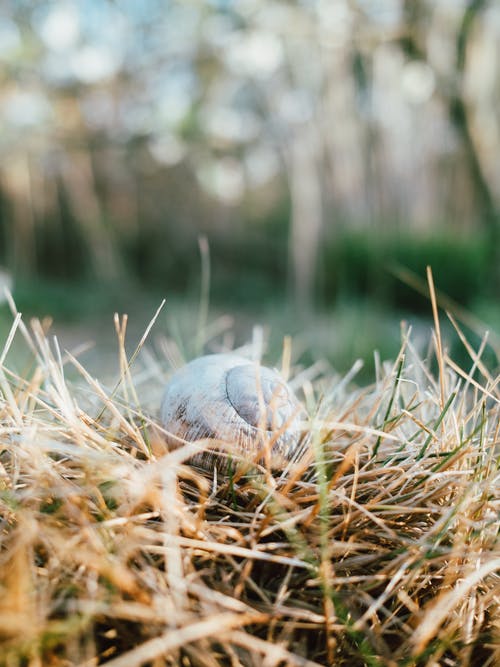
[160,354,305,470]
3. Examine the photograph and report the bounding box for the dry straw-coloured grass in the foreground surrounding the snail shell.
[0,298,500,667]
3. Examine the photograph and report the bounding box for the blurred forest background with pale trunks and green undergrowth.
[0,0,500,372]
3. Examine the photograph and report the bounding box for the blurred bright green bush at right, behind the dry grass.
[322,231,494,313]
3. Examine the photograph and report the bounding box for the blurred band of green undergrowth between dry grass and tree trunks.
[0,228,500,382]
